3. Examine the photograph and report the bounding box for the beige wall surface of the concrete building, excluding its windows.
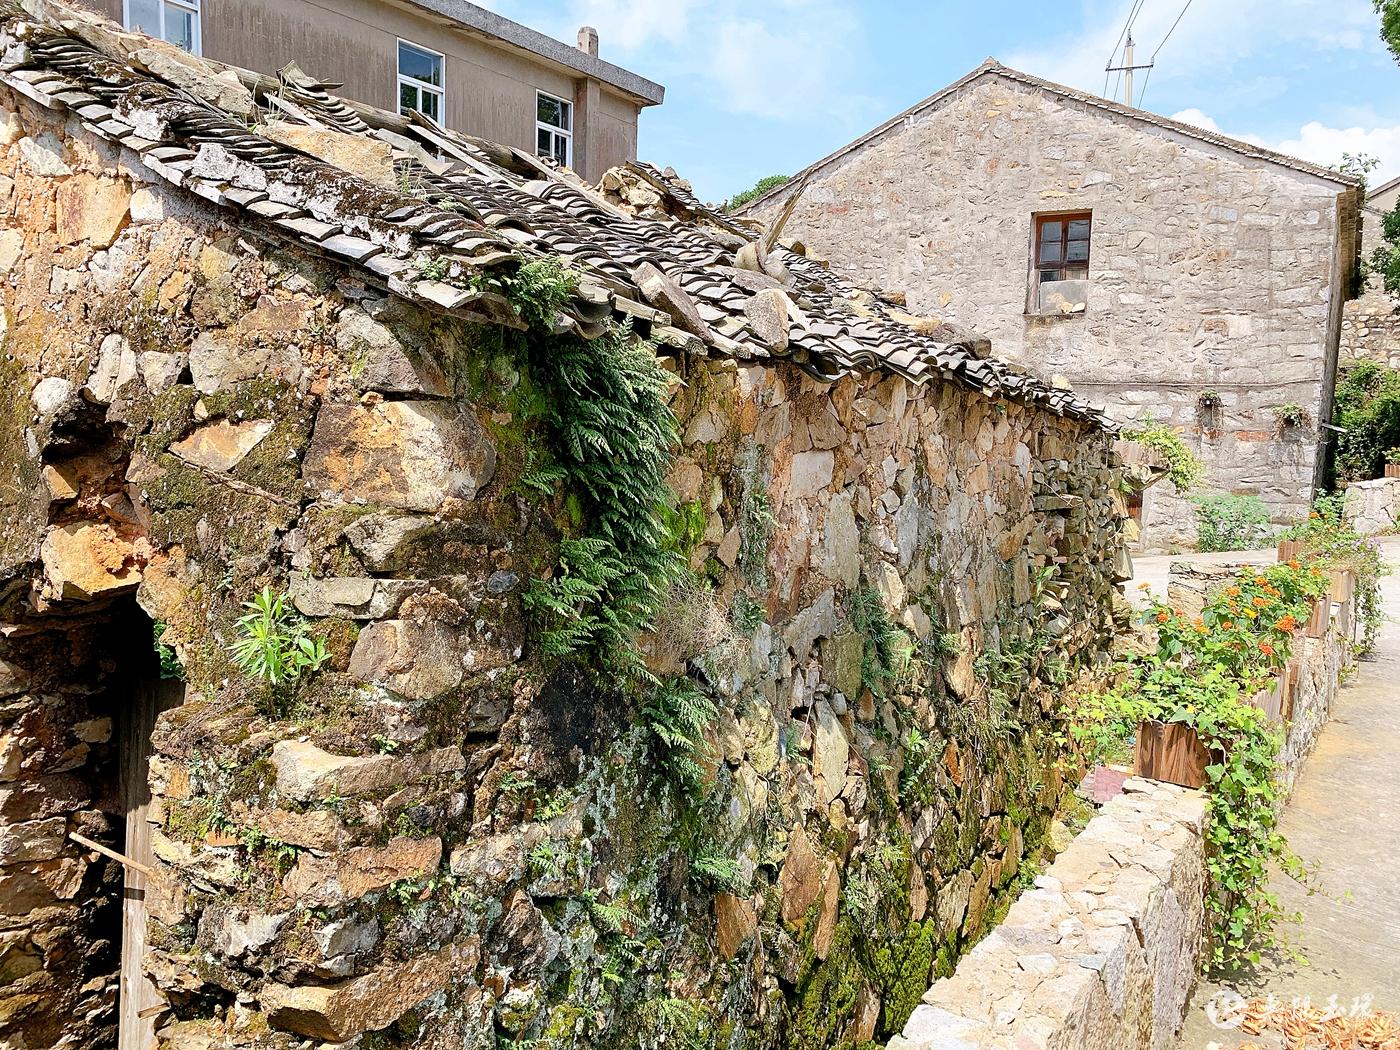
[78,0,640,179]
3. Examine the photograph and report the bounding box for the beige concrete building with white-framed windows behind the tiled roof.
[79,0,665,179]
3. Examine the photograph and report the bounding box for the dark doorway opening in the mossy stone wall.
[0,594,183,1050]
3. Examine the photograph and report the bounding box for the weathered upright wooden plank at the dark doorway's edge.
[118,679,185,1050]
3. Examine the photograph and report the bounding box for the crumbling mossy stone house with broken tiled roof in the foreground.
[0,8,1126,1050]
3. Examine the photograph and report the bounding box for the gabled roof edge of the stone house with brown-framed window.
[739,59,1361,214]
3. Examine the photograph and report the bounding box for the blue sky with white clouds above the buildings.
[486,0,1400,200]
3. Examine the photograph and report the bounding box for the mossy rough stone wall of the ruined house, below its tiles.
[0,88,1127,1049]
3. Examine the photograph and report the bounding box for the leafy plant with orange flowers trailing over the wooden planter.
[1072,561,1327,967]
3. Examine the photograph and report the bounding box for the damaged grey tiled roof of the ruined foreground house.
[0,0,1113,430]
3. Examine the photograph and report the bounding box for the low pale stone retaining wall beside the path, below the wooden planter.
[889,778,1205,1050]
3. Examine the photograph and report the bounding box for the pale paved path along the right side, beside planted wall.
[1138,540,1400,1050]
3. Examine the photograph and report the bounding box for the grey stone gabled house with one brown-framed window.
[749,60,1359,546]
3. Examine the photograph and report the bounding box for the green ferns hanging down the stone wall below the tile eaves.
[525,326,685,679]
